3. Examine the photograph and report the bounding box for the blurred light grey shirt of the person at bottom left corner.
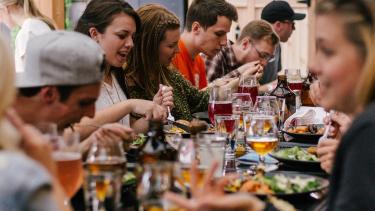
[0,151,58,211]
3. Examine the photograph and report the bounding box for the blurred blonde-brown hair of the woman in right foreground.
[316,0,375,111]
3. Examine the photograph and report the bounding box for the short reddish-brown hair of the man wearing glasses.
[237,20,279,46]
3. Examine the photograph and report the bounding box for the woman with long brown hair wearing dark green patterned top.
[125,4,238,120]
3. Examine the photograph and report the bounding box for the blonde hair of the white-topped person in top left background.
[0,0,56,30]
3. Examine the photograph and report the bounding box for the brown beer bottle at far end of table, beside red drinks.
[270,75,296,120]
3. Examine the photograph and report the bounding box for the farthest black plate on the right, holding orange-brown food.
[282,124,324,143]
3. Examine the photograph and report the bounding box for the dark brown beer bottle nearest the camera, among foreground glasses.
[141,121,177,164]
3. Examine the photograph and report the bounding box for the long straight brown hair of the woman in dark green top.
[125,4,180,97]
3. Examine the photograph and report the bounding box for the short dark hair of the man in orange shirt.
[185,0,238,31]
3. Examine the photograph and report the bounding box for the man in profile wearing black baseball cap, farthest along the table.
[260,1,306,84]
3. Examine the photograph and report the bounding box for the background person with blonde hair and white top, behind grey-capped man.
[0,0,56,72]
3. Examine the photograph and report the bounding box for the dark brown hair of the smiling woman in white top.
[74,0,141,36]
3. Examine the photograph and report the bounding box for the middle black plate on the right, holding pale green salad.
[269,146,321,170]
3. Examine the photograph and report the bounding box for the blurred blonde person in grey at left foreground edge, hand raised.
[0,37,71,211]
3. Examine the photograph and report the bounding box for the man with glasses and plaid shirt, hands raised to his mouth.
[205,20,279,85]
